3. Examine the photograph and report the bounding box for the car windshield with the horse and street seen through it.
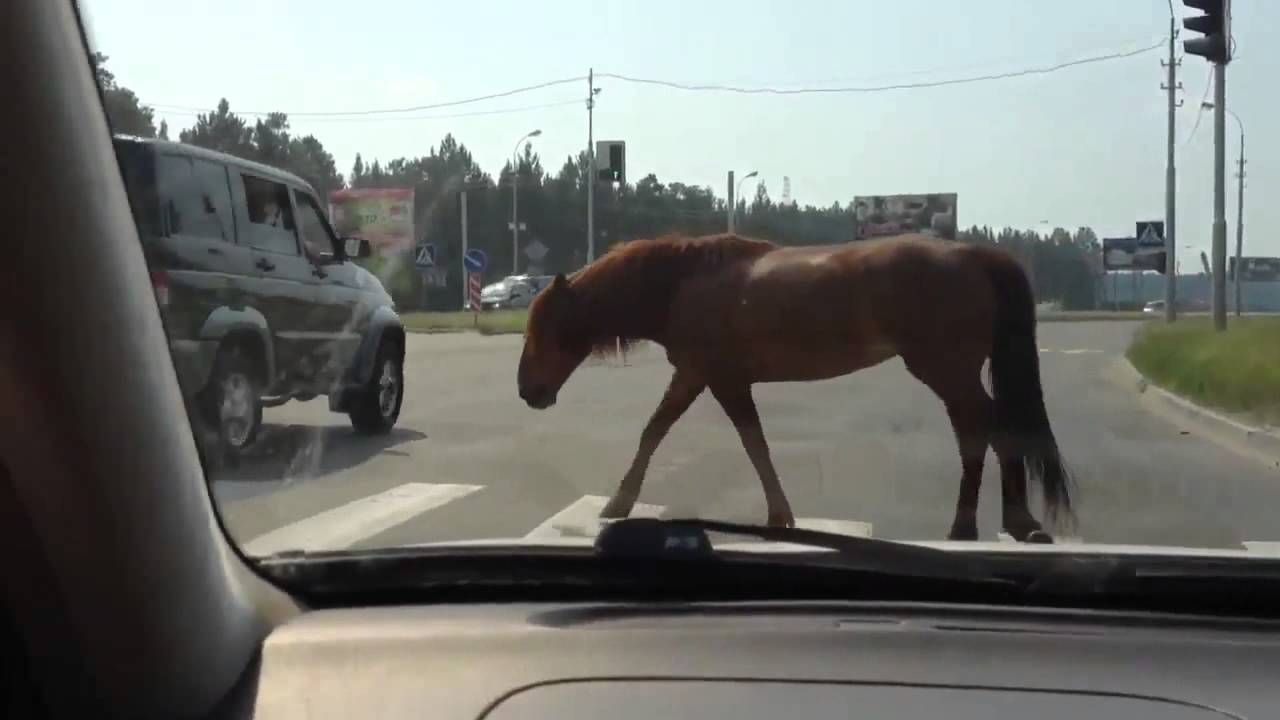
[82,0,1280,566]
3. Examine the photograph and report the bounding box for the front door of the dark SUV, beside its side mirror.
[293,188,369,382]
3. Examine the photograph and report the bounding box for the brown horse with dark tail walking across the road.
[517,234,1071,542]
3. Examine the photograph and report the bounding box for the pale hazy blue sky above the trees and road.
[81,0,1280,257]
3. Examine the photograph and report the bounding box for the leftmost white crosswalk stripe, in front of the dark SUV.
[243,483,484,555]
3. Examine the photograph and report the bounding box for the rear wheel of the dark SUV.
[205,345,262,461]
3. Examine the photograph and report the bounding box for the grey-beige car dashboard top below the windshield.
[240,602,1280,720]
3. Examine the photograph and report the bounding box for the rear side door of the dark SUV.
[232,168,329,393]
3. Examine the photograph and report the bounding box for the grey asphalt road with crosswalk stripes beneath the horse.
[211,322,1280,553]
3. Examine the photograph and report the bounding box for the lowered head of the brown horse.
[516,274,591,410]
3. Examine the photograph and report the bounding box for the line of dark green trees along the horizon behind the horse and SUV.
[93,54,1101,309]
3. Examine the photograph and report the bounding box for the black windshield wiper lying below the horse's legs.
[594,518,1009,584]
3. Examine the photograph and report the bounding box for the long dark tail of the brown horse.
[987,256,1074,521]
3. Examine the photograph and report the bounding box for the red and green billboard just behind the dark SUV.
[329,187,413,258]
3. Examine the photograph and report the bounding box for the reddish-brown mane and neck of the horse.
[568,233,777,357]
